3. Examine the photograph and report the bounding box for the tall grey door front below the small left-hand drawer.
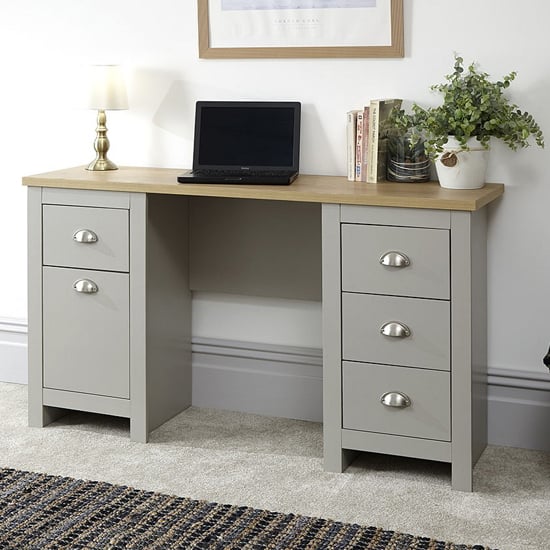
[43,267,130,399]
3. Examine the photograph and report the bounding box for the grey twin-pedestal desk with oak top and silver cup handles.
[23,167,504,490]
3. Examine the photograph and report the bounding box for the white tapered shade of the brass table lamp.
[88,65,128,111]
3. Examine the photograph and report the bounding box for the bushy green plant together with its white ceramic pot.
[392,56,544,189]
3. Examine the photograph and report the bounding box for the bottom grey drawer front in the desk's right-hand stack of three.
[343,362,451,441]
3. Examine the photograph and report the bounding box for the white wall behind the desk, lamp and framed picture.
[0,0,550,372]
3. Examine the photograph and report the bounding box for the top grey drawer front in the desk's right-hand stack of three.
[342,224,449,299]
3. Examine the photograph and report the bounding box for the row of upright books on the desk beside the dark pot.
[346,99,402,183]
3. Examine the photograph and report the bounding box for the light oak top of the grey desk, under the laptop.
[23,166,504,211]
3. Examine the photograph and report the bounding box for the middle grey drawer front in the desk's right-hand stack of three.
[342,293,450,370]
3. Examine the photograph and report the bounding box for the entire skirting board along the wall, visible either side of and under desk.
[0,320,550,451]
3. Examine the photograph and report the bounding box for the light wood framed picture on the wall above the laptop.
[197,0,404,59]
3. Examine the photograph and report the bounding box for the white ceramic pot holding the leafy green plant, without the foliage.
[435,136,489,189]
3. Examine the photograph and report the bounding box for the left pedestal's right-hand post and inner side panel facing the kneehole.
[130,193,191,443]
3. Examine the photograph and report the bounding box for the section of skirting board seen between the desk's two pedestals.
[191,338,323,422]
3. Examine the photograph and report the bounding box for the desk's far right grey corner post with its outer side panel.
[451,209,487,491]
